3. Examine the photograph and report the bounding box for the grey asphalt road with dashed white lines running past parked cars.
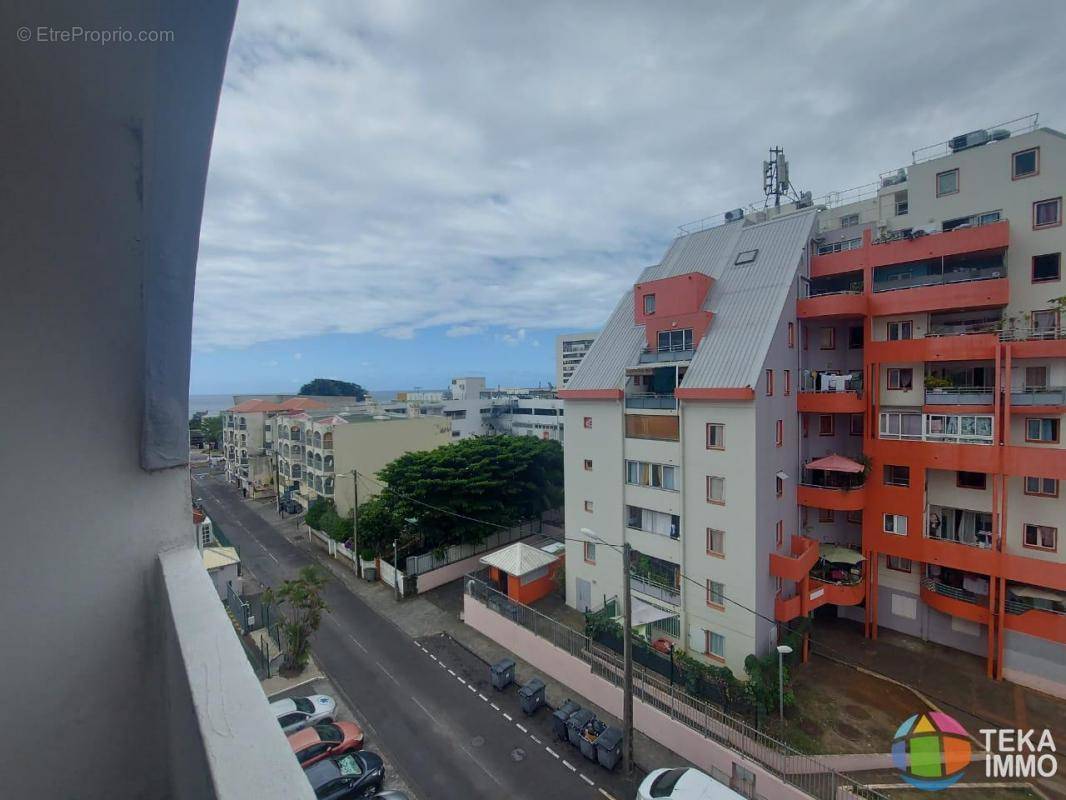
[193,473,628,800]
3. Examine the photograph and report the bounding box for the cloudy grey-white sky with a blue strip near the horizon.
[192,0,1066,394]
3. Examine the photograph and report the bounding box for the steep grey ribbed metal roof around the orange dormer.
[566,209,817,390]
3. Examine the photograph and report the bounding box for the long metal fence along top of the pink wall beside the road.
[465,575,887,800]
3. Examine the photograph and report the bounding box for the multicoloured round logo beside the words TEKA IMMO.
[892,711,972,791]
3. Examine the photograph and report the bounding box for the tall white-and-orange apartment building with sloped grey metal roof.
[560,126,1066,694]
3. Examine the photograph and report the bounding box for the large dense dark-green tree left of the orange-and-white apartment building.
[359,436,563,554]
